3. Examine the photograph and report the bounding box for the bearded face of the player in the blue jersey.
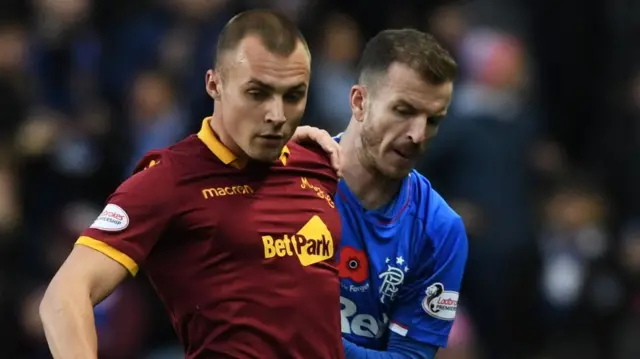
[351,64,453,179]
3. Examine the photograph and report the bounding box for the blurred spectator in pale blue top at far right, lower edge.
[540,180,623,356]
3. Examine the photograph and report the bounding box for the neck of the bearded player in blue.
[340,119,402,209]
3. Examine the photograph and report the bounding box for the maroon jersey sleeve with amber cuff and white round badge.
[76,156,174,276]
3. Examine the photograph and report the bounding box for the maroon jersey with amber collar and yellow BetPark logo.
[77,120,343,359]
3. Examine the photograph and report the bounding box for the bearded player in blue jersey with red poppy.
[296,29,468,359]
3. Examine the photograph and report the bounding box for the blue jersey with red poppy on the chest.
[335,171,468,350]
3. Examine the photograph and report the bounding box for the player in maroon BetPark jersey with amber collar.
[40,10,344,359]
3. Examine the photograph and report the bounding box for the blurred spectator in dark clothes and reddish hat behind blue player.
[422,28,540,359]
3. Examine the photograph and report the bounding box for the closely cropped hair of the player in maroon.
[216,10,308,67]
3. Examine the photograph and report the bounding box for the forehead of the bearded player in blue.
[379,63,453,112]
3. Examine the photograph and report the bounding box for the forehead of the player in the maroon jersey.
[227,36,311,87]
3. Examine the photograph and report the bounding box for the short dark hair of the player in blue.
[358,29,458,85]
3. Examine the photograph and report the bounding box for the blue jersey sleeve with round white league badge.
[389,216,469,347]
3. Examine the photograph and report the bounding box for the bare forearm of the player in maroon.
[40,285,98,359]
